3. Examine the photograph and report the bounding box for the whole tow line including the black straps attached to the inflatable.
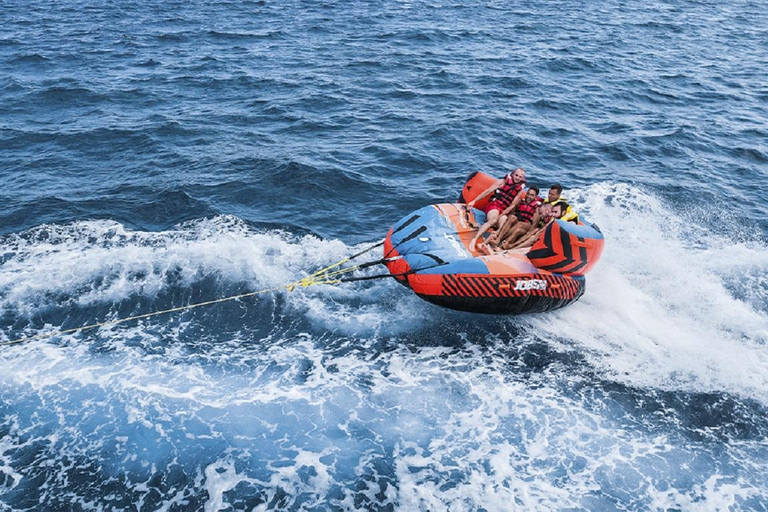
[0,240,396,346]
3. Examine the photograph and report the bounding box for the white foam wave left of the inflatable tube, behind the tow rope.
[0,216,427,344]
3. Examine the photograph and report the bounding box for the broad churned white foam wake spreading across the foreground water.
[2,316,763,511]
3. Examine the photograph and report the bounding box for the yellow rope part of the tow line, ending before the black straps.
[0,258,360,346]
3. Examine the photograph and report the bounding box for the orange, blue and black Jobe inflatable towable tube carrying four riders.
[384,173,605,314]
